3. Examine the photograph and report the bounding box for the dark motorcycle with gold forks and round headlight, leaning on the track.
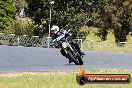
[50,30,83,65]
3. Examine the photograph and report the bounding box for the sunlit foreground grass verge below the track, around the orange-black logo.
[0,70,132,88]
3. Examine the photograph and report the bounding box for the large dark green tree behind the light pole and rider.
[27,0,93,36]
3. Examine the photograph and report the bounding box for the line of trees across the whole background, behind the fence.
[0,0,132,42]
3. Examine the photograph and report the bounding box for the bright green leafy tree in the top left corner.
[0,0,16,33]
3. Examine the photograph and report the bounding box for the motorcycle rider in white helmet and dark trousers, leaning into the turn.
[51,25,85,64]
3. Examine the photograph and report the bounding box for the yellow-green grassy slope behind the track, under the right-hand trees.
[82,28,132,52]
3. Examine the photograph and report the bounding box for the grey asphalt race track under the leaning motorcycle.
[0,45,132,72]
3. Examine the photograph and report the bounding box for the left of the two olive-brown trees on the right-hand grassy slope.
[88,0,112,41]
